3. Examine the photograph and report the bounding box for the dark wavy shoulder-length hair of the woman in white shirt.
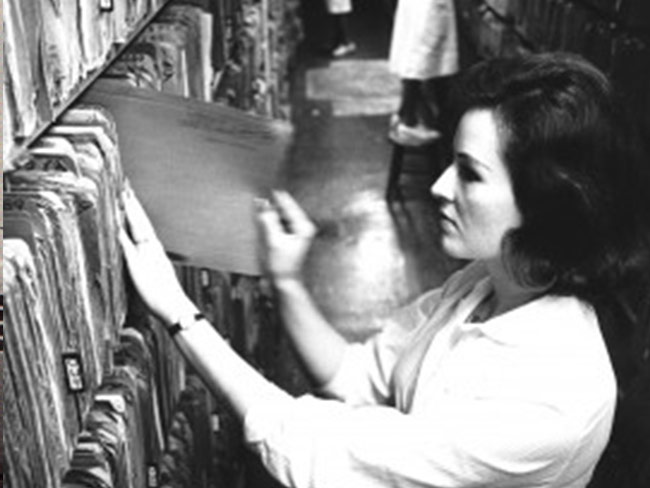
[458,53,650,303]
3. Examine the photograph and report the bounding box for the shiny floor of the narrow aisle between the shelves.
[286,1,457,337]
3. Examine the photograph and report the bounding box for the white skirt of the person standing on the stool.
[389,0,458,80]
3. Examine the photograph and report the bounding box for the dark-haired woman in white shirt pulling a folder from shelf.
[121,54,650,488]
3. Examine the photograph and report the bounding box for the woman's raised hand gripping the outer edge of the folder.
[257,191,316,284]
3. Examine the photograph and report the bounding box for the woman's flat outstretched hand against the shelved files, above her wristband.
[120,187,196,325]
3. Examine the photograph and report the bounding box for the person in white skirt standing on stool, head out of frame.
[388,0,458,146]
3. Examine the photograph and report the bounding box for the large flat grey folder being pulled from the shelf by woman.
[81,80,292,275]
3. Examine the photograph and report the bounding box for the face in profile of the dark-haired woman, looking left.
[431,109,521,260]
